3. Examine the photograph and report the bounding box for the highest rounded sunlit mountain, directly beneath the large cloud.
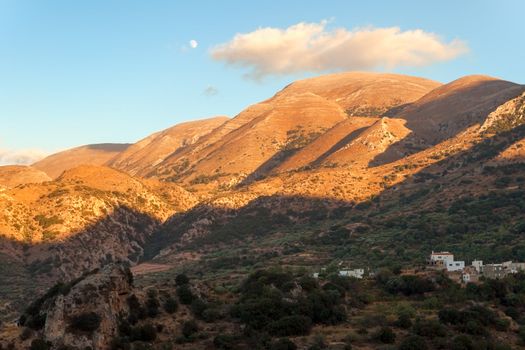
[152,73,441,187]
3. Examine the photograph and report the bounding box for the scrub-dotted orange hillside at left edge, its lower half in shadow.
[0,166,196,315]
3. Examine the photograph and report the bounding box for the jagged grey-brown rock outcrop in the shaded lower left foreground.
[21,264,133,349]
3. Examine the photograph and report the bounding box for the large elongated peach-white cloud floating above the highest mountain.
[211,21,468,79]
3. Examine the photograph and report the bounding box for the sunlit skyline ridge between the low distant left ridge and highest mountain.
[106,117,228,176]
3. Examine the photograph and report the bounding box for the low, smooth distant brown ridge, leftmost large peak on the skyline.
[32,143,130,178]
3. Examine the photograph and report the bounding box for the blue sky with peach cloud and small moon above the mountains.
[0,0,525,164]
